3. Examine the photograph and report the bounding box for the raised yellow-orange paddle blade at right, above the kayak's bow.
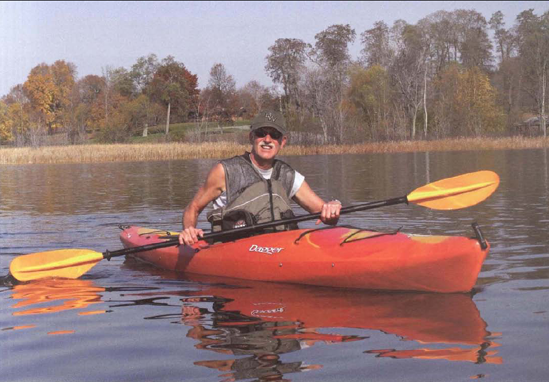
[407,171,499,210]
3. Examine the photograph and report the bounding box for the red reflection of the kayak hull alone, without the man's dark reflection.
[172,276,490,345]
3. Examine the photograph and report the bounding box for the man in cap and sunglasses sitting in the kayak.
[179,111,341,245]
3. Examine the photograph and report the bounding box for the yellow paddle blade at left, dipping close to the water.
[10,249,103,281]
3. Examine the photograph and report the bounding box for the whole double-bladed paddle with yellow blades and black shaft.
[10,171,499,281]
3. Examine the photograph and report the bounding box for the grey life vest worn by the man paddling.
[208,152,296,232]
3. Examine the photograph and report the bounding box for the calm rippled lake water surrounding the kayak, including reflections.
[0,149,549,382]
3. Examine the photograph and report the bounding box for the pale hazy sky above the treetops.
[0,1,549,96]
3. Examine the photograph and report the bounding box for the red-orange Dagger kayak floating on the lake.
[120,226,490,293]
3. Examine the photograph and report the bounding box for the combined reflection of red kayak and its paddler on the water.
[122,261,501,379]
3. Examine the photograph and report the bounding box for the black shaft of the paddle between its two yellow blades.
[103,196,408,260]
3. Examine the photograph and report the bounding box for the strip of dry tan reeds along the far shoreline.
[0,137,549,164]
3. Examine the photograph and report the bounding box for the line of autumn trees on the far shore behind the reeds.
[0,10,549,145]
